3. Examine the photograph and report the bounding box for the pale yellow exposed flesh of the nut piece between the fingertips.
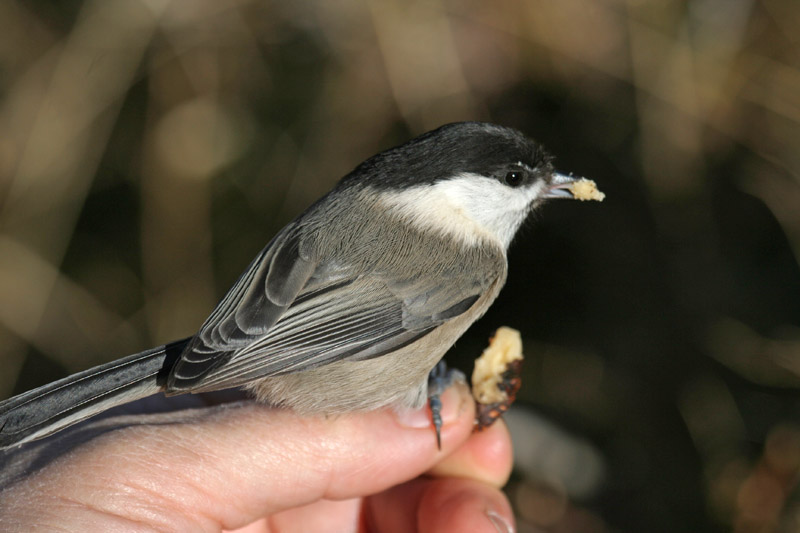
[472,327,522,404]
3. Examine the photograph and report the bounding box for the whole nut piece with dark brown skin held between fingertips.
[472,327,522,431]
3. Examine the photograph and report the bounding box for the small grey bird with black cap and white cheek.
[0,122,588,447]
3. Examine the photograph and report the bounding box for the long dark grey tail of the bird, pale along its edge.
[0,340,187,448]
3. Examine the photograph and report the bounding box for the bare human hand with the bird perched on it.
[0,383,513,533]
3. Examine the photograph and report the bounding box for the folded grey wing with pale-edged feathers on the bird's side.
[169,225,493,392]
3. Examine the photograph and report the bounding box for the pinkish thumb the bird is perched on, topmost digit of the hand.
[0,384,474,531]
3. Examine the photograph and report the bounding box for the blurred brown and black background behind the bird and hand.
[0,0,800,532]
